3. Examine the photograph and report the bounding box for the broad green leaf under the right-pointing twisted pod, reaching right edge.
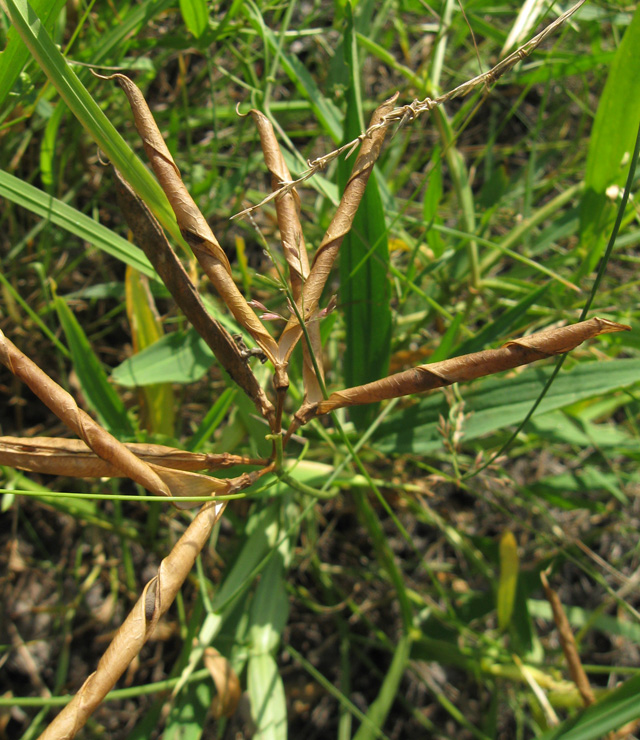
[375,359,640,454]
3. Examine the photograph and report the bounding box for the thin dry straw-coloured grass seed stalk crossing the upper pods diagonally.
[232,0,586,218]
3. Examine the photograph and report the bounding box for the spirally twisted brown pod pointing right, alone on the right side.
[306,318,630,419]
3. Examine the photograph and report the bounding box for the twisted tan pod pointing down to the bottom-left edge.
[40,501,225,740]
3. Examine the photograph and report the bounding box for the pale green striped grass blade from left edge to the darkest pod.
[0,170,159,281]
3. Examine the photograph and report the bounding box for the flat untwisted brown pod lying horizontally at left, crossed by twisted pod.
[0,437,269,478]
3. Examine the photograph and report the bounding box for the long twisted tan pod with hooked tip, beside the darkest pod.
[99,74,277,364]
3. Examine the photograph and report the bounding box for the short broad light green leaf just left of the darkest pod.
[111,329,215,388]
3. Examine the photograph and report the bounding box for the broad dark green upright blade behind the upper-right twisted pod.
[338,4,391,429]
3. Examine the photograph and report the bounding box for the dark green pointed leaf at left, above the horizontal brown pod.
[53,296,134,439]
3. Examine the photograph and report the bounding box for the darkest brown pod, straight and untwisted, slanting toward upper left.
[114,168,274,426]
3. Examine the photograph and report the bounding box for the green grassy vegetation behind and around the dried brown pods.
[0,0,640,740]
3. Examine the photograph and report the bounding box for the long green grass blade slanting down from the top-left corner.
[4,0,180,238]
